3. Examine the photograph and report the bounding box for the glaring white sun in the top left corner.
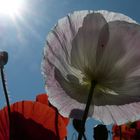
[0,0,23,17]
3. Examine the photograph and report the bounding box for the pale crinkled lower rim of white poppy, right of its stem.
[93,102,140,125]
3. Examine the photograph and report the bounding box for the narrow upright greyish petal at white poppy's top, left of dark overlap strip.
[71,13,106,76]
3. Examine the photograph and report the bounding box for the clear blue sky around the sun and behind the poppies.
[0,0,140,140]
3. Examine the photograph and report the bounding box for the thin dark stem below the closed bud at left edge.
[0,67,11,140]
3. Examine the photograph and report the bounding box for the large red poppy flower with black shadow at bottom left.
[0,94,68,140]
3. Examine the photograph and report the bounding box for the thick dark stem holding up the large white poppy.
[78,80,96,140]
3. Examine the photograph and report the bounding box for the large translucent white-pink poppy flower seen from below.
[42,11,140,124]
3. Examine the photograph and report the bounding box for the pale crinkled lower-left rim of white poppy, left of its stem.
[42,60,85,117]
